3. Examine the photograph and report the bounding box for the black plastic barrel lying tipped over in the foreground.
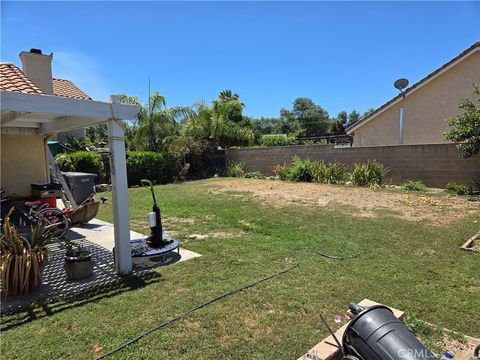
[343,304,438,360]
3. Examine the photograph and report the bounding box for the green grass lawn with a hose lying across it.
[1,180,480,359]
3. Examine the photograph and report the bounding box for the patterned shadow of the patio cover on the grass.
[0,271,162,331]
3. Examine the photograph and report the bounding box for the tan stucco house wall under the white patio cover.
[0,134,50,196]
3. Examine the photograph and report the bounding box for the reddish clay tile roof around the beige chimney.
[0,63,92,100]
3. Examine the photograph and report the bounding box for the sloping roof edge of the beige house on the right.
[346,41,480,135]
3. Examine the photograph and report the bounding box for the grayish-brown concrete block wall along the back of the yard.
[226,144,480,187]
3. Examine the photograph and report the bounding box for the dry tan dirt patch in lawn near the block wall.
[206,178,480,226]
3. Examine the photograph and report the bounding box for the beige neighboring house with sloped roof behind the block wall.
[347,42,480,147]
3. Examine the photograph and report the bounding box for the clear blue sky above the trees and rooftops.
[1,1,480,117]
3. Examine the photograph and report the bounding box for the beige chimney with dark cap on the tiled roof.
[20,49,53,95]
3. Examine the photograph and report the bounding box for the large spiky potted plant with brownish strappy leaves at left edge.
[0,208,58,298]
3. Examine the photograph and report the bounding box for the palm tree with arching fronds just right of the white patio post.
[118,92,191,151]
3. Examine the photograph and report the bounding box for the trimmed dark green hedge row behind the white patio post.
[55,151,182,186]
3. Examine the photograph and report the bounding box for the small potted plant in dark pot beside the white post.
[63,237,95,280]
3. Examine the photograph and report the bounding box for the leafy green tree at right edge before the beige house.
[444,84,480,157]
